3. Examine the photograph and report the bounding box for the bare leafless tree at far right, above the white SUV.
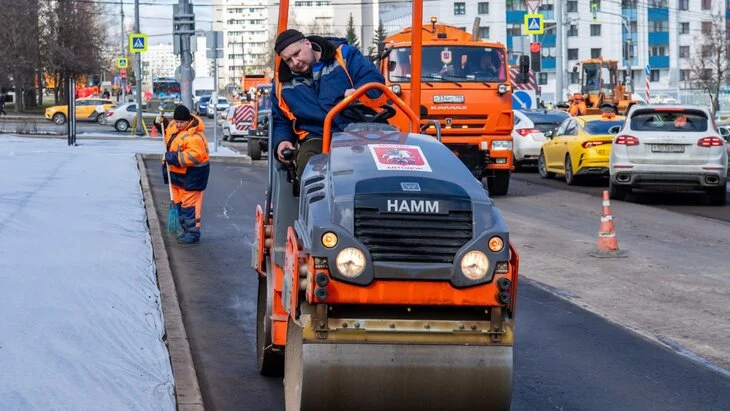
[690,15,730,114]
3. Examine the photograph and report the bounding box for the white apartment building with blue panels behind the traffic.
[382,0,730,101]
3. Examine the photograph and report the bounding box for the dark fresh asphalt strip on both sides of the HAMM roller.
[146,157,730,411]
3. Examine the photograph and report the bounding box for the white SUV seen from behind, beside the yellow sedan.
[609,104,728,205]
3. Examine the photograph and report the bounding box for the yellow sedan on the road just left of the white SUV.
[537,113,625,185]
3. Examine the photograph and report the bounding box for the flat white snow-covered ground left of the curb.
[0,137,237,411]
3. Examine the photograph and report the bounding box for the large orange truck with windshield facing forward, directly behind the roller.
[379,19,514,195]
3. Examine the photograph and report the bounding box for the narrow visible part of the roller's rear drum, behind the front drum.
[256,262,284,377]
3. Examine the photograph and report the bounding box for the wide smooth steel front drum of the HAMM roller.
[284,316,513,411]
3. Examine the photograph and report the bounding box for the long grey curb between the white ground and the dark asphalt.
[136,154,205,411]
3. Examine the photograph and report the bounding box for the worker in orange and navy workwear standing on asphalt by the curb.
[163,104,210,244]
